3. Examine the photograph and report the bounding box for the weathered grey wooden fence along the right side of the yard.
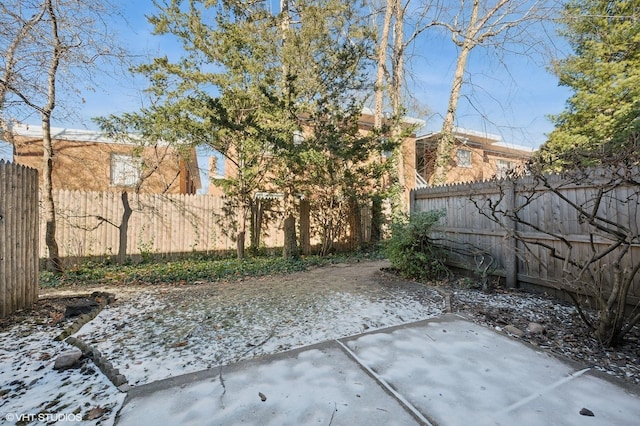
[411,176,640,304]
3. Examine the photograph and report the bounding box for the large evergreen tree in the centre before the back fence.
[102,0,378,257]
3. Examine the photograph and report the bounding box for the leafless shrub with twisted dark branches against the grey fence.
[472,148,640,346]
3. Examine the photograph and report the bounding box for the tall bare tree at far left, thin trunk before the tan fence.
[0,0,125,273]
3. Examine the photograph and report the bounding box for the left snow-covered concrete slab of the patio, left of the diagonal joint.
[119,344,416,426]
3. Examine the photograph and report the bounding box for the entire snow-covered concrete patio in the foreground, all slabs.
[119,315,640,426]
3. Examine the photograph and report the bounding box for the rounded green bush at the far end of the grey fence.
[385,210,448,280]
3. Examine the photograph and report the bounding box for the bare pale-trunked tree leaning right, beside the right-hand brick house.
[431,0,554,185]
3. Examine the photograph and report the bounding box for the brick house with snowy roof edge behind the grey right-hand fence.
[415,128,535,187]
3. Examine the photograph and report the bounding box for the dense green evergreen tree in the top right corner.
[540,0,640,167]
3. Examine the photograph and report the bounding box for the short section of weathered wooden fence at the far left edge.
[0,160,39,318]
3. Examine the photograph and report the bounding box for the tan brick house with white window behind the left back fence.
[5,125,200,194]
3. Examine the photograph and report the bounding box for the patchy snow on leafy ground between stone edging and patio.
[75,280,442,386]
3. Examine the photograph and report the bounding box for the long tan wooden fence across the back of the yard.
[45,190,371,261]
